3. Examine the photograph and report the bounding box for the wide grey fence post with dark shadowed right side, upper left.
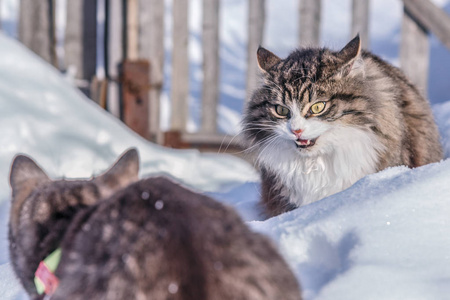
[64,0,97,96]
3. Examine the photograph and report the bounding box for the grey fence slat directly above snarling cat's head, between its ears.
[299,0,322,47]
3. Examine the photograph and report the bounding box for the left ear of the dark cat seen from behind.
[9,155,51,203]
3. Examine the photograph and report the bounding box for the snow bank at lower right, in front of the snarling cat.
[252,160,450,300]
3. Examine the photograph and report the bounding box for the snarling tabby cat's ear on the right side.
[336,34,364,77]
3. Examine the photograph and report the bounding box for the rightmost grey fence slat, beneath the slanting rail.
[400,9,430,95]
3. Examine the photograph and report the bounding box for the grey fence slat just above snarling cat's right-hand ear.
[350,0,370,49]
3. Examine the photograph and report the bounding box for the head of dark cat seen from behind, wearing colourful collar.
[9,149,139,292]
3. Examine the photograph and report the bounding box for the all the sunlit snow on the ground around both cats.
[0,32,450,300]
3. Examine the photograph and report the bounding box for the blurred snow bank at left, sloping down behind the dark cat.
[0,34,258,299]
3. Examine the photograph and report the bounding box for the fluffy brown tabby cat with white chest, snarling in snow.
[242,36,443,217]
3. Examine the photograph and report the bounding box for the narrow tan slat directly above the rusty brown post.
[126,0,139,60]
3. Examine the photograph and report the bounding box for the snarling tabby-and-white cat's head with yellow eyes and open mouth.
[242,36,374,162]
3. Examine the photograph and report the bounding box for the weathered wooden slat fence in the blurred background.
[12,0,450,152]
